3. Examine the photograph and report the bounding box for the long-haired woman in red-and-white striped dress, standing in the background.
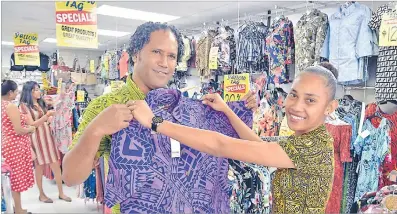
[20,81,72,203]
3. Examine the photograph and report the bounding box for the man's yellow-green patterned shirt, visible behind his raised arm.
[69,76,145,157]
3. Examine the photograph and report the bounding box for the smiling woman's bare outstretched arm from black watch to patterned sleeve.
[157,121,295,168]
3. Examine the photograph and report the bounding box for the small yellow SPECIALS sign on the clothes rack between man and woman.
[223,74,250,102]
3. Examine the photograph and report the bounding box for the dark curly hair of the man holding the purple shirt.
[128,22,184,65]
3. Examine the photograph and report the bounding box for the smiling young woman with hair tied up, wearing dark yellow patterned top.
[130,63,338,213]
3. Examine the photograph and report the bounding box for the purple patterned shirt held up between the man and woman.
[105,89,252,213]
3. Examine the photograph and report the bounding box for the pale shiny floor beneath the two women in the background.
[22,178,103,213]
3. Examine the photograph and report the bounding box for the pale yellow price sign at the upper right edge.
[379,13,397,47]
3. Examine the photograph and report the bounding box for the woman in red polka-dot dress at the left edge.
[1,80,35,214]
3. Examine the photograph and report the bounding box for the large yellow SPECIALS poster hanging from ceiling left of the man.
[55,1,98,49]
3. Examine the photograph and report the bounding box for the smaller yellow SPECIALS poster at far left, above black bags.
[14,32,40,66]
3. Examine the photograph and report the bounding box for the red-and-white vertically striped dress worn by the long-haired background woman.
[20,104,60,165]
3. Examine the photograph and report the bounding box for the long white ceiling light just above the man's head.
[97,5,180,22]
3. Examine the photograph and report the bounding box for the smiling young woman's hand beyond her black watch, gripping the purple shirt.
[130,100,154,128]
